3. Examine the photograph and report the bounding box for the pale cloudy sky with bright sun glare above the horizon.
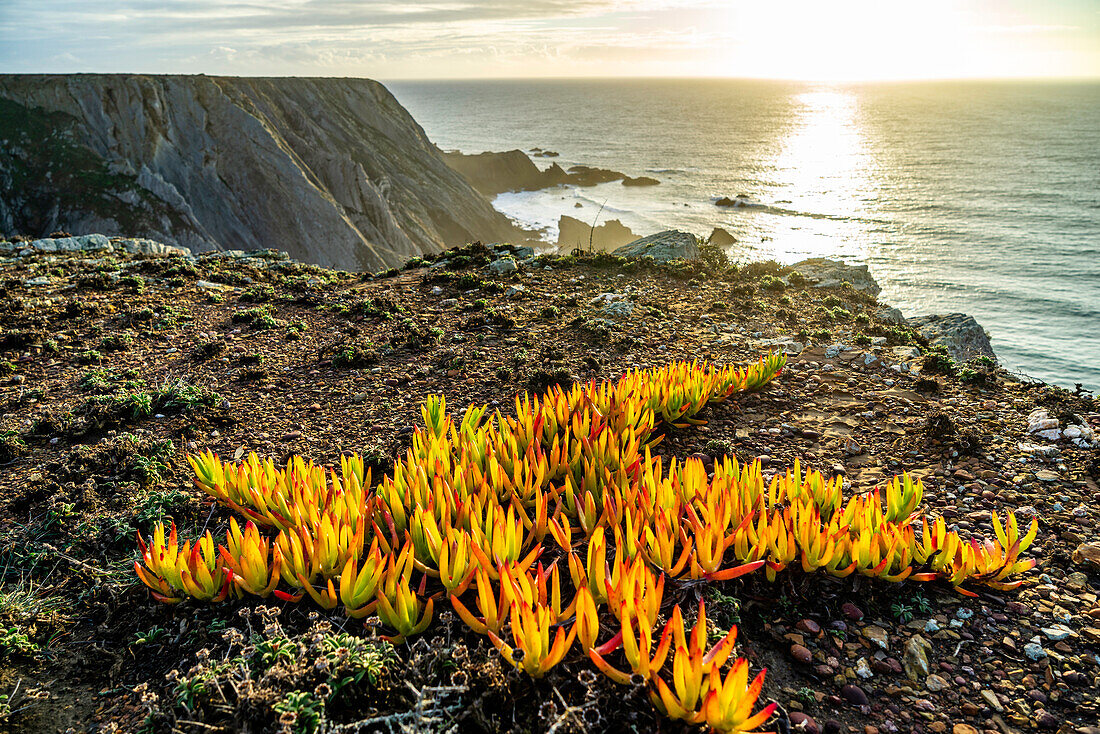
[0,0,1100,81]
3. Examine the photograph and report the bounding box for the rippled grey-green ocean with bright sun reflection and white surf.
[388,79,1100,391]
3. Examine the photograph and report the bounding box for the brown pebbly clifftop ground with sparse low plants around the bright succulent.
[0,235,1100,734]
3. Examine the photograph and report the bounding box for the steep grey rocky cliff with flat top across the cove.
[0,75,517,269]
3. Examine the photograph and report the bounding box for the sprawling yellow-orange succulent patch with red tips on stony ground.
[134,354,1037,732]
